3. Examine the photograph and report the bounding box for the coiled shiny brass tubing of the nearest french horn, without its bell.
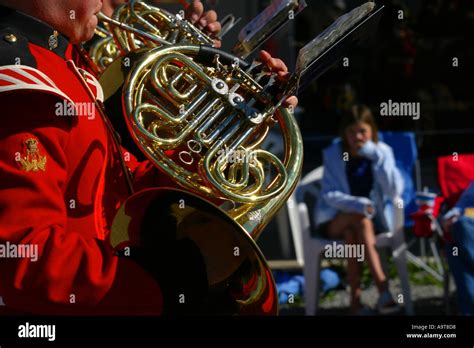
[123,45,303,239]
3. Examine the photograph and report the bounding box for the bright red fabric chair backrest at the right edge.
[438,154,474,207]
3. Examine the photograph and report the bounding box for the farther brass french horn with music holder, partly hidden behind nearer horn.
[88,0,306,74]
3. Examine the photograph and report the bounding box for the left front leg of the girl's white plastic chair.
[304,253,321,315]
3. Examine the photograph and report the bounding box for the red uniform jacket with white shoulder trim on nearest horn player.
[0,9,162,314]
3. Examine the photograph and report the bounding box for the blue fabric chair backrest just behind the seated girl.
[379,132,418,227]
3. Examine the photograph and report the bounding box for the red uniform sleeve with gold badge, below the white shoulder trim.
[0,91,162,314]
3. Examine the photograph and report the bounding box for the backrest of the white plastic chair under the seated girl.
[287,166,323,264]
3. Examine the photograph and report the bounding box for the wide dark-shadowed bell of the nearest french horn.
[111,189,278,315]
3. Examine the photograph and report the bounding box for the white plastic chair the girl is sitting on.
[287,167,413,315]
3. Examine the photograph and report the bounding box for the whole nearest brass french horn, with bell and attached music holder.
[104,3,386,314]
